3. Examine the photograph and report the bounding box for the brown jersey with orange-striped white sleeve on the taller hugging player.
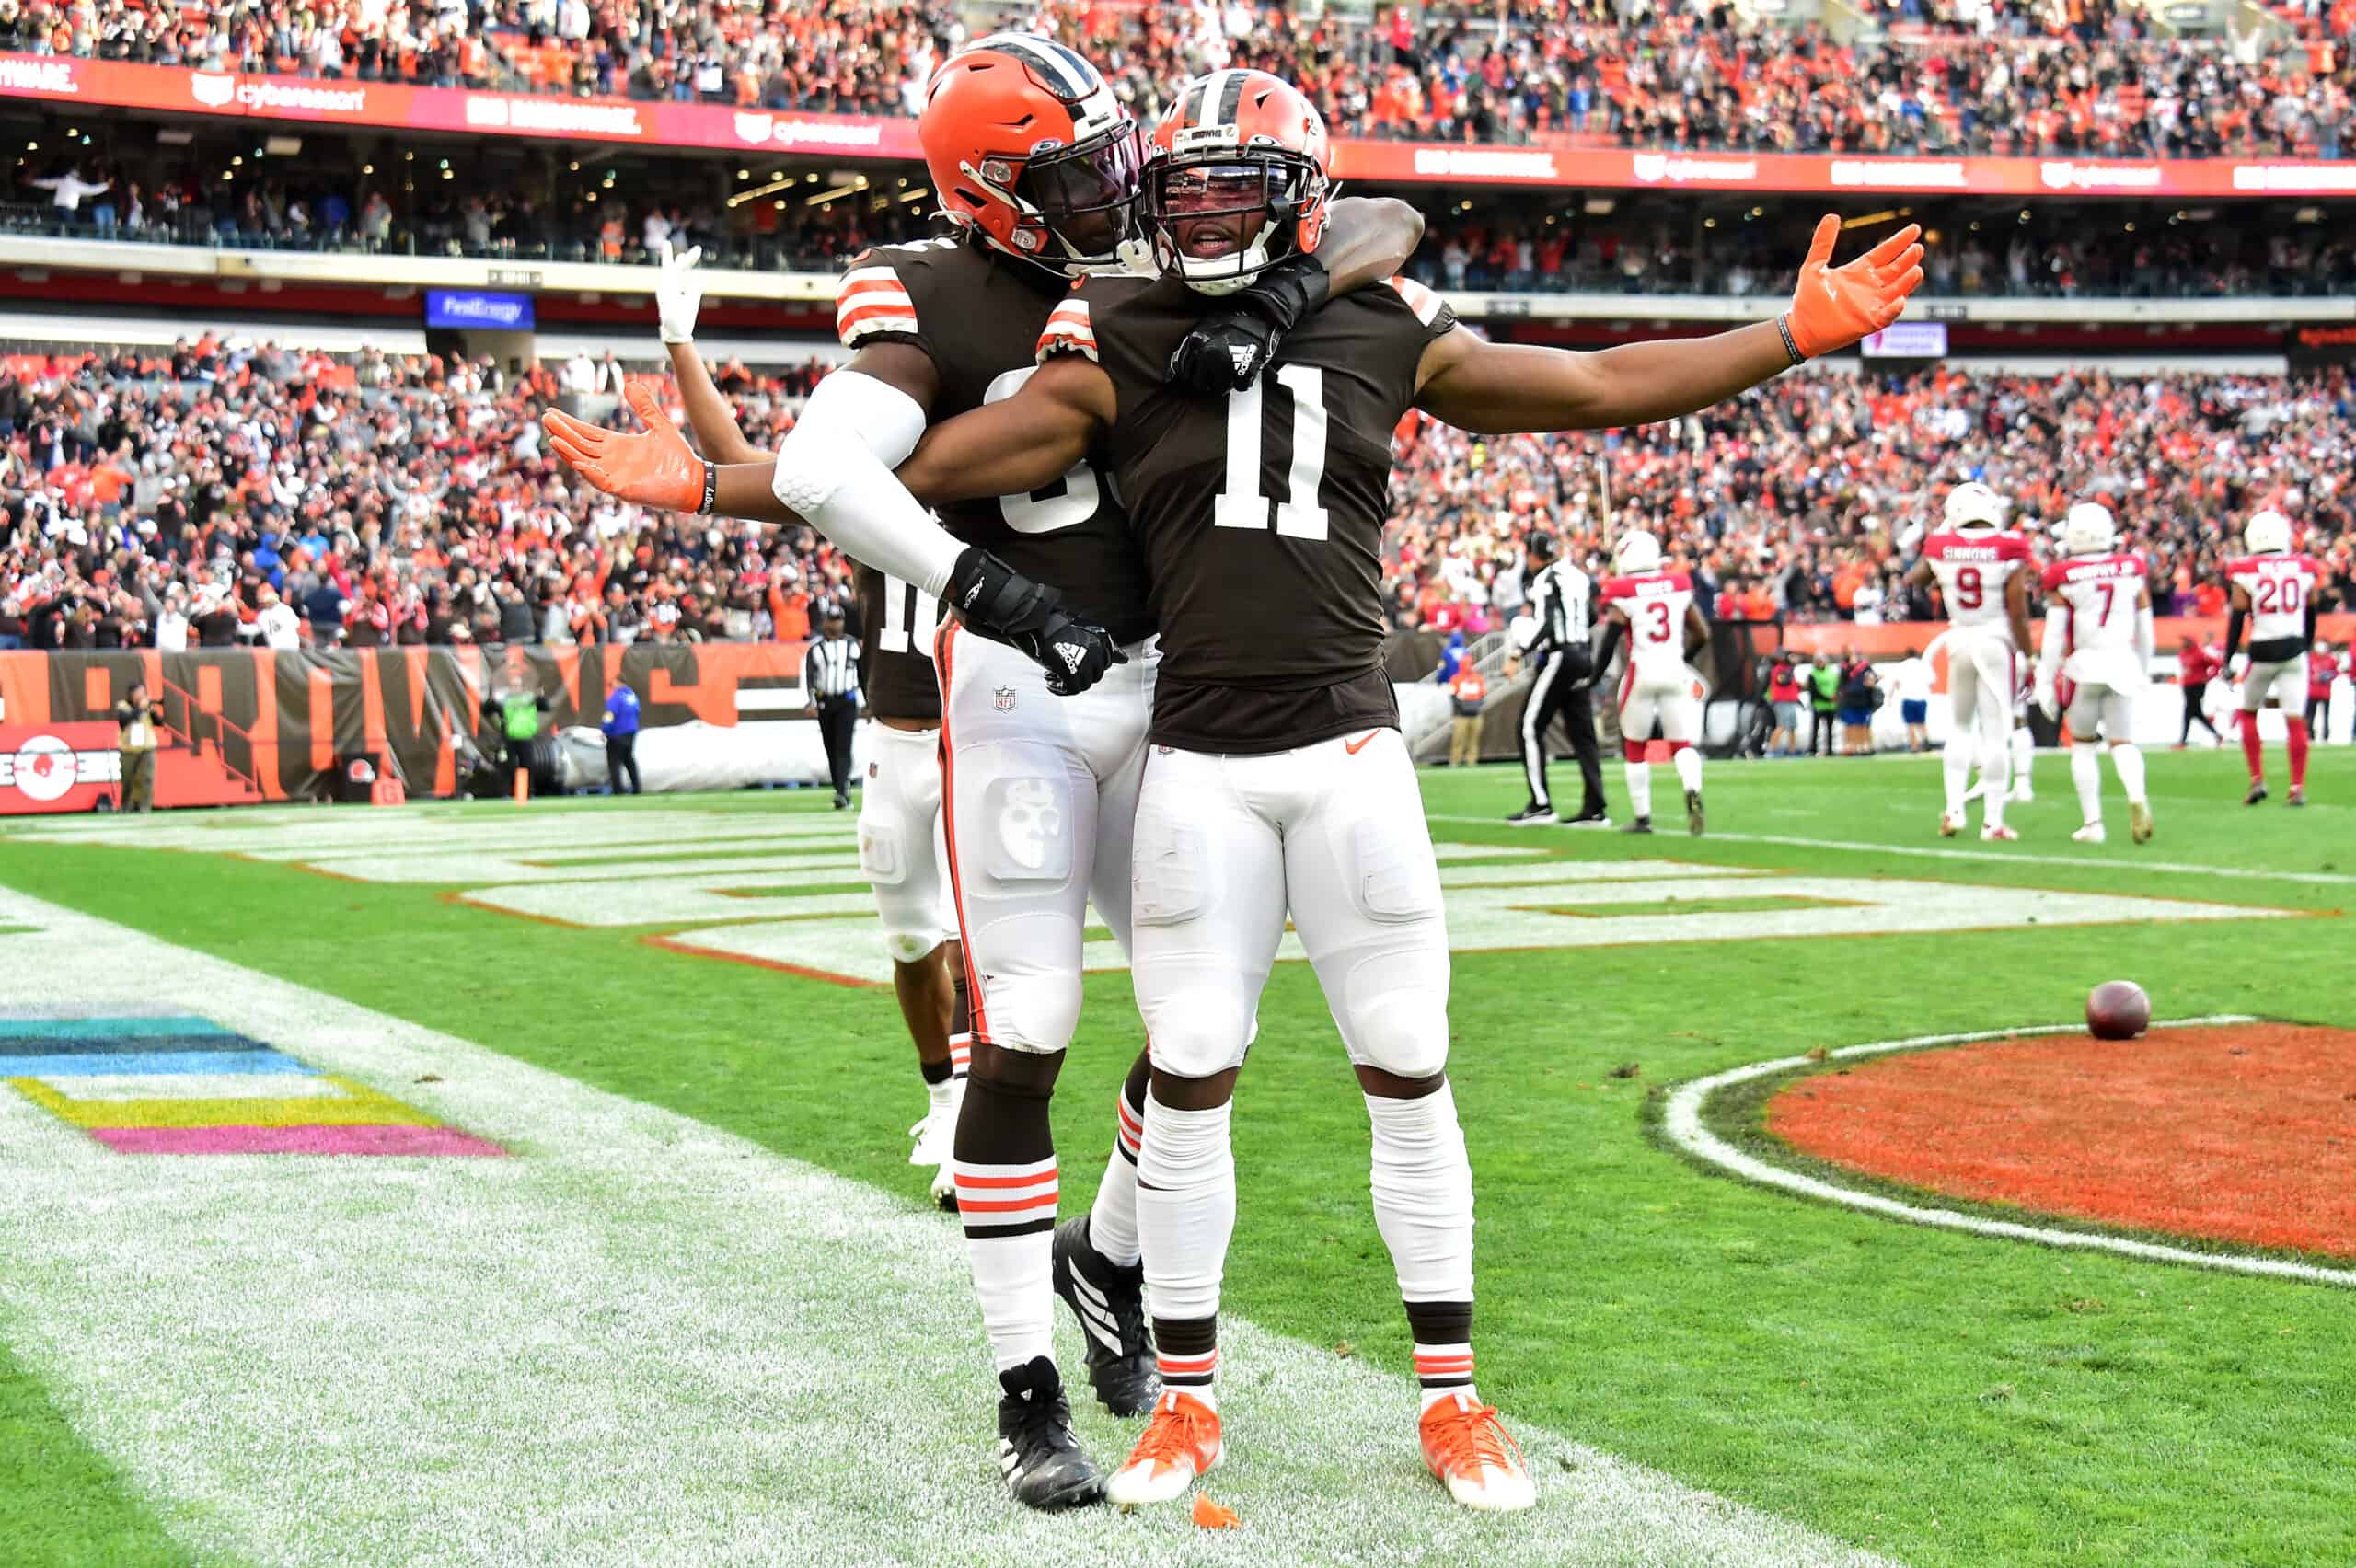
[834,240,1154,642]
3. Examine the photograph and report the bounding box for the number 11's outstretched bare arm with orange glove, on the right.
[1416,214,1923,433]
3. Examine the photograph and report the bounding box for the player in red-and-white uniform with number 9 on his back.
[1906,483,2028,840]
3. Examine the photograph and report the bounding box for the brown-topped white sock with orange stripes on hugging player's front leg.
[950,1078,1056,1373]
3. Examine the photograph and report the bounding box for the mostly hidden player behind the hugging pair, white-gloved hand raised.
[655,240,973,1208]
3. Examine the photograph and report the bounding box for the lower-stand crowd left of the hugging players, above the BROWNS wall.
[0,337,850,648]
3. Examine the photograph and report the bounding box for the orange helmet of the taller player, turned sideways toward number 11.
[917,33,1143,278]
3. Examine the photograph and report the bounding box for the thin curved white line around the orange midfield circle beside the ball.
[1663,1012,2356,1288]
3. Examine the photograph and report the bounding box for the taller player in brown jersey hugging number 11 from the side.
[549,35,1421,1506]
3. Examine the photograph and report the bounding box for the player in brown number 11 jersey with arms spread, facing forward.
[876,71,1923,1509]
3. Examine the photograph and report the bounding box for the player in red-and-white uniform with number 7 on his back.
[2038,502,2151,843]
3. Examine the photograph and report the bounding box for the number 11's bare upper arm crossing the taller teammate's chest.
[900,353,1114,506]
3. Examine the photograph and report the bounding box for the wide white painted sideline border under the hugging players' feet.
[0,888,1885,1568]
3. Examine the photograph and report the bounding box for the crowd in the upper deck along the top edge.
[0,0,2356,157]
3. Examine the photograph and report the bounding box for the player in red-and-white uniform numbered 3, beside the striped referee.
[1595,530,1711,834]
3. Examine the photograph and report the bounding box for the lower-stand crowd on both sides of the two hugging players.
[0,337,2356,648]
